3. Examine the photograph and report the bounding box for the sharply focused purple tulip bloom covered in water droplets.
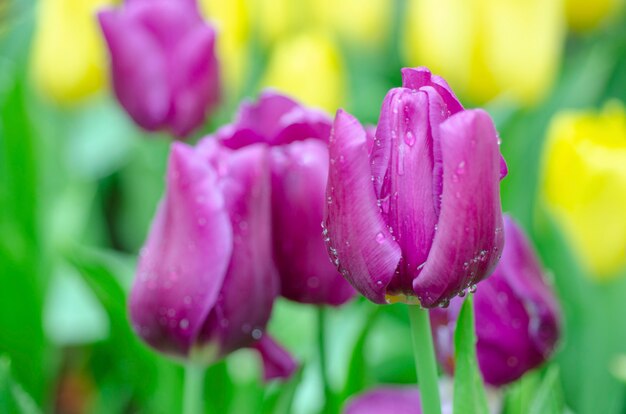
[324,68,506,308]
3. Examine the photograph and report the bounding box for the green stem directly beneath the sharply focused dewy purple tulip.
[409,305,441,414]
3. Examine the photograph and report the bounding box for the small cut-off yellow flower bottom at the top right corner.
[565,0,624,31]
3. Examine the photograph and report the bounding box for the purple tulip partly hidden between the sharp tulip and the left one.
[216,91,355,305]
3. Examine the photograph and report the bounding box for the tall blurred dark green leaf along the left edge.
[0,64,51,402]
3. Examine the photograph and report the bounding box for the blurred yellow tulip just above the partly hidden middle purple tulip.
[262,31,345,113]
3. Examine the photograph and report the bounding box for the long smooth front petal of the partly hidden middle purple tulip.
[271,139,355,305]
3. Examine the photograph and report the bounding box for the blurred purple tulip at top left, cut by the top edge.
[98,0,220,137]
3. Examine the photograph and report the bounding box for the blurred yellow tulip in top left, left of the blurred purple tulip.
[31,0,116,103]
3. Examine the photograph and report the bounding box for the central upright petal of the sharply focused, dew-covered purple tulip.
[371,88,438,296]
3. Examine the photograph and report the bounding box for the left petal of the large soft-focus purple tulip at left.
[129,143,233,356]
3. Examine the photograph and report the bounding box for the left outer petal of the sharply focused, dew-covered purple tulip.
[325,110,401,303]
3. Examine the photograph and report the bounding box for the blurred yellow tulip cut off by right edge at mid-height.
[542,102,626,280]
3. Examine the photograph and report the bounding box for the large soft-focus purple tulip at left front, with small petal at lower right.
[130,141,295,377]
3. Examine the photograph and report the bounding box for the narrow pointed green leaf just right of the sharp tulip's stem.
[454,295,489,414]
